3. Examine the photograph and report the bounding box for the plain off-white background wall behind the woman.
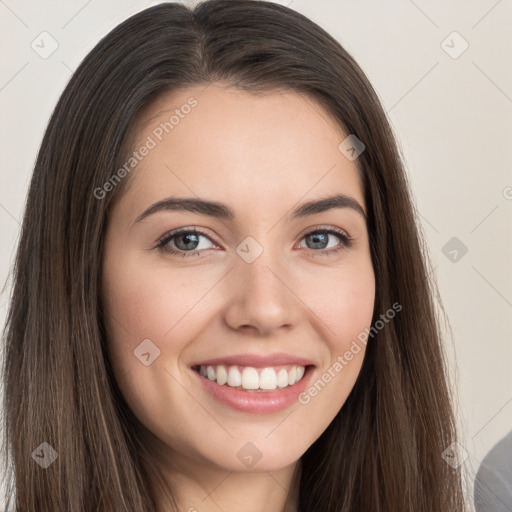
[0,0,512,508]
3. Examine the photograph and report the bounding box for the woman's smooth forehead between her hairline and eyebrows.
[120,84,364,218]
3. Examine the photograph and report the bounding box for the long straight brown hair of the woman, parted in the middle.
[3,0,463,512]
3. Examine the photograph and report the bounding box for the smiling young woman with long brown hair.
[0,0,463,512]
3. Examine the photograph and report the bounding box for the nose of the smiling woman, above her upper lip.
[225,248,304,336]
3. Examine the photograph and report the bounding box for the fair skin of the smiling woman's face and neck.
[102,83,375,512]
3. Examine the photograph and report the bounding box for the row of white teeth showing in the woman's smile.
[199,365,305,390]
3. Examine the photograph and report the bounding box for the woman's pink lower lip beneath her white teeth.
[192,366,314,414]
